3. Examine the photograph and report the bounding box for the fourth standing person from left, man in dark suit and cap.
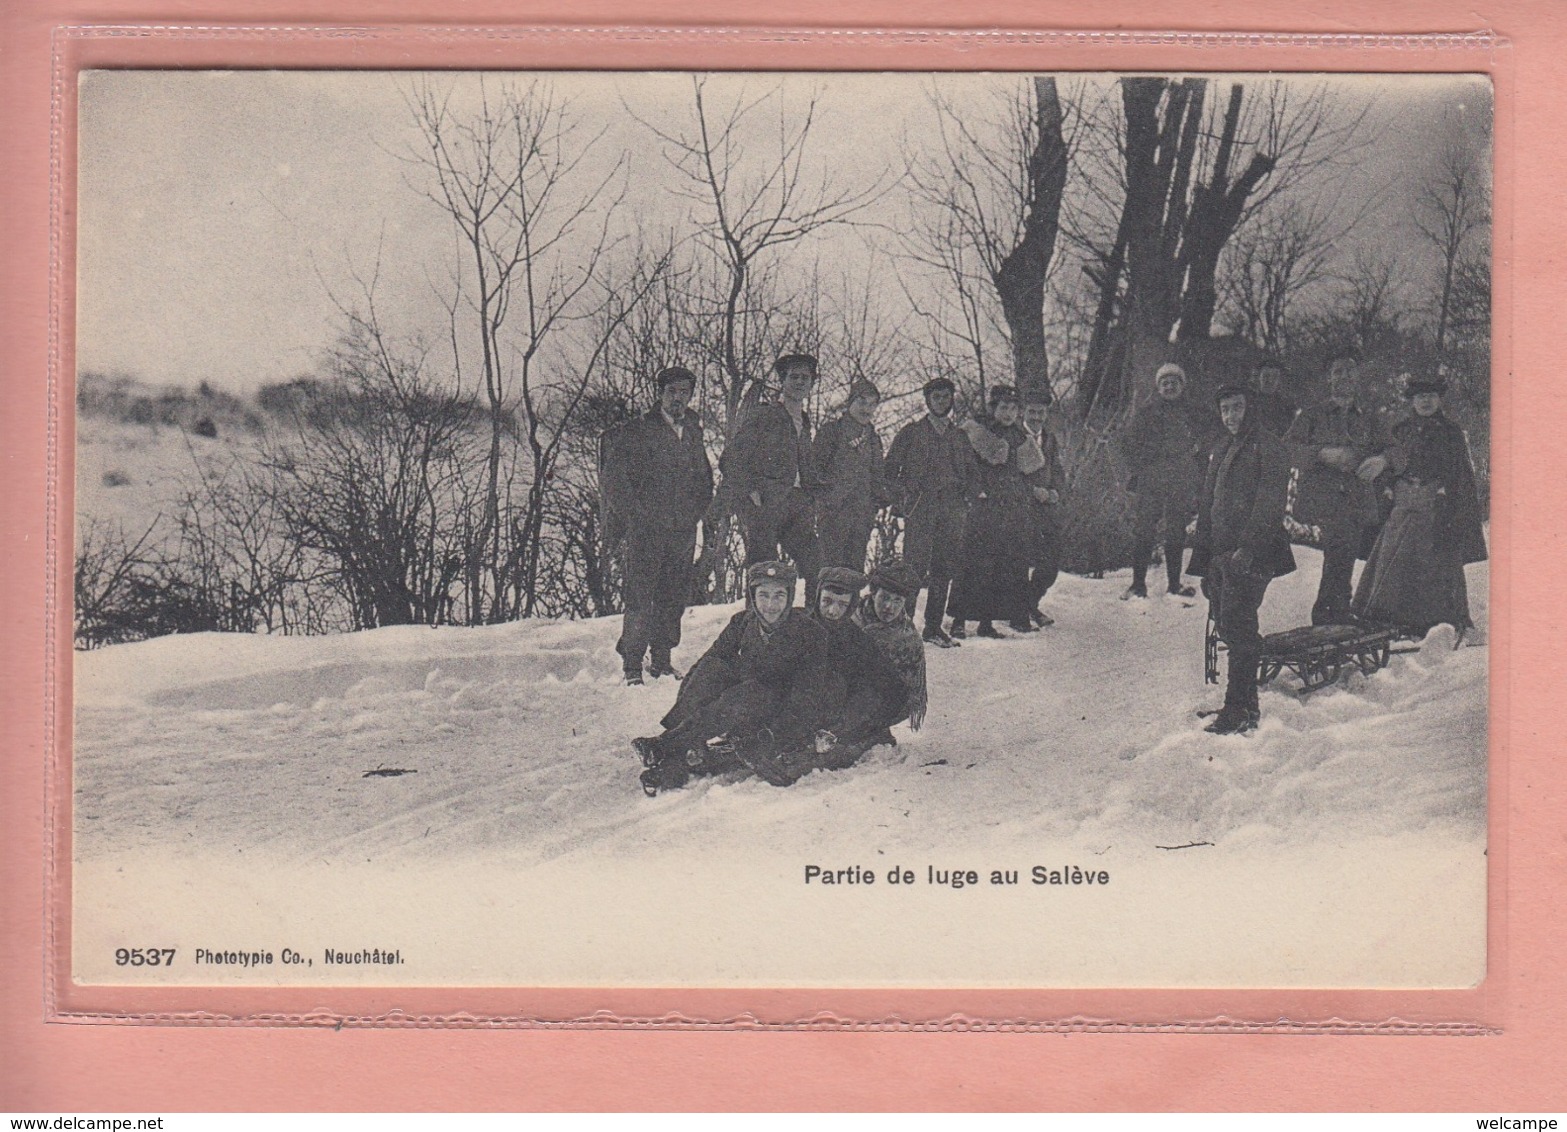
[887,378,975,648]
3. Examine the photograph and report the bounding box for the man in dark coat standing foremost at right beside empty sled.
[1191,386,1294,735]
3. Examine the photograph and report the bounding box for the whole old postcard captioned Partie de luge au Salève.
[69,69,1493,988]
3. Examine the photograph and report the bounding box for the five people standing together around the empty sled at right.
[1122,354,1486,734]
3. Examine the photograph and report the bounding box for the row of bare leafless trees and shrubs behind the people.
[77,75,1490,646]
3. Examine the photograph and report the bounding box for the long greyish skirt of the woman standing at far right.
[1354,480,1473,637]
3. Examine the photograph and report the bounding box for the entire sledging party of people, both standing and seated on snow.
[600,343,1486,780]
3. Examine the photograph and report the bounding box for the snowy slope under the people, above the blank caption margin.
[77,552,1487,858]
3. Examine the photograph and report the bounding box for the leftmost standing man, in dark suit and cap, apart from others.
[602,365,713,684]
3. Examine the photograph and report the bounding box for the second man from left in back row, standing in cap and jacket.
[719,354,821,604]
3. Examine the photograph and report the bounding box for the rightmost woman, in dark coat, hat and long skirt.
[1354,378,1486,637]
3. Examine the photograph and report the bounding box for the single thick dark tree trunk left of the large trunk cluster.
[995,77,1067,400]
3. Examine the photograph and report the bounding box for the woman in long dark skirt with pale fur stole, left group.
[950,386,1045,637]
